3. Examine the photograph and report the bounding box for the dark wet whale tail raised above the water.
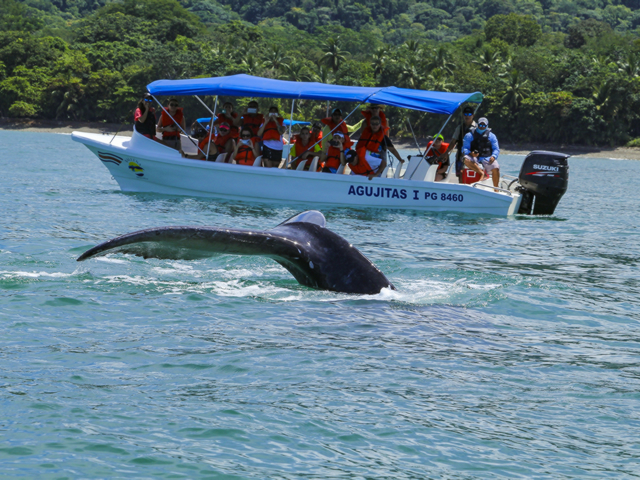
[78,210,395,295]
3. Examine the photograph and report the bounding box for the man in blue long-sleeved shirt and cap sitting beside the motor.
[462,117,500,187]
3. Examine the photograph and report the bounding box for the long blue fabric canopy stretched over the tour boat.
[147,74,482,114]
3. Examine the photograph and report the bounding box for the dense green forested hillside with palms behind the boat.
[0,0,640,144]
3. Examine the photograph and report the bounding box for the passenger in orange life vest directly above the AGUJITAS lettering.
[348,117,404,180]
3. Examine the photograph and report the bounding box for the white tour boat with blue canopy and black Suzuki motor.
[72,75,568,216]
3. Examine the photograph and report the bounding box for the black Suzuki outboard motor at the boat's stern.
[518,150,570,215]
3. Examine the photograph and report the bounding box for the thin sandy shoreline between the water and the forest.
[5,118,640,160]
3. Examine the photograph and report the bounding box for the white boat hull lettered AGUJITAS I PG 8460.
[72,132,520,216]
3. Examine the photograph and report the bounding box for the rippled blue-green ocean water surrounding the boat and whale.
[0,131,640,479]
